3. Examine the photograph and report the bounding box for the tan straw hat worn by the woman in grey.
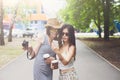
[45,18,61,29]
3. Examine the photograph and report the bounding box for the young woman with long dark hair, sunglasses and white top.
[51,24,78,80]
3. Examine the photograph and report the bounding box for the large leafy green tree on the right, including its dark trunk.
[58,0,116,40]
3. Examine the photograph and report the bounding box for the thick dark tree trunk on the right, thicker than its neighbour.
[103,0,110,40]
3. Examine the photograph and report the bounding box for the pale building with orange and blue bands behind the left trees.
[3,0,47,29]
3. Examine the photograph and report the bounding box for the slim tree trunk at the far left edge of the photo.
[0,0,5,45]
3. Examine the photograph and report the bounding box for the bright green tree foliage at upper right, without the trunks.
[59,0,120,31]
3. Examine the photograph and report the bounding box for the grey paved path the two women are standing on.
[0,40,120,80]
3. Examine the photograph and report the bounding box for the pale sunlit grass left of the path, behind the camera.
[0,38,35,68]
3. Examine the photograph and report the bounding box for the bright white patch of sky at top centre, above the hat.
[41,0,66,18]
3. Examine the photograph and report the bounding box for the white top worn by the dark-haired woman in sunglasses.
[57,52,74,70]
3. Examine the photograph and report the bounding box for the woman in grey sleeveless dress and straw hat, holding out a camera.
[22,18,60,80]
